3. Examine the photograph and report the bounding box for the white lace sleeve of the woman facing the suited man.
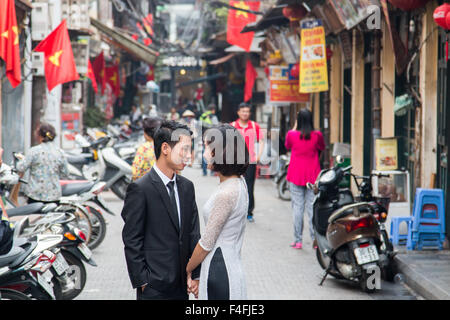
[199,184,239,251]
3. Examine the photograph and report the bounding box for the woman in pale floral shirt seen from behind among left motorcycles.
[17,123,69,203]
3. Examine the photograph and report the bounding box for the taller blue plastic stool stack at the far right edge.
[406,188,445,250]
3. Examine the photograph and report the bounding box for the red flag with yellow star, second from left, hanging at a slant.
[34,20,80,91]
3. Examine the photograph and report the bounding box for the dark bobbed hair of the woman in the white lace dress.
[204,124,250,177]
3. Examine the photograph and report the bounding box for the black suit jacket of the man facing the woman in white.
[122,169,200,293]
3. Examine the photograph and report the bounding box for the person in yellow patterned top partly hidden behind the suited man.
[131,117,163,181]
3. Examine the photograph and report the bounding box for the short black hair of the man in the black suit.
[153,120,192,159]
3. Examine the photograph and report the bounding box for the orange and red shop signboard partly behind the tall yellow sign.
[269,65,309,103]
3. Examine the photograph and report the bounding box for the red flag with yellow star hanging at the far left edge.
[0,0,22,88]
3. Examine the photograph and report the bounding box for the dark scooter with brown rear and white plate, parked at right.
[308,158,396,292]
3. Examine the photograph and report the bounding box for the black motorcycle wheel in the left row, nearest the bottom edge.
[52,249,86,300]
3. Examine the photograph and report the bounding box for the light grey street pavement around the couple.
[77,168,420,300]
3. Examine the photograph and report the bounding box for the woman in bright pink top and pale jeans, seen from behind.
[285,109,325,249]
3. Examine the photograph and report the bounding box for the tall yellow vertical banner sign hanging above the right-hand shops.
[300,20,328,93]
